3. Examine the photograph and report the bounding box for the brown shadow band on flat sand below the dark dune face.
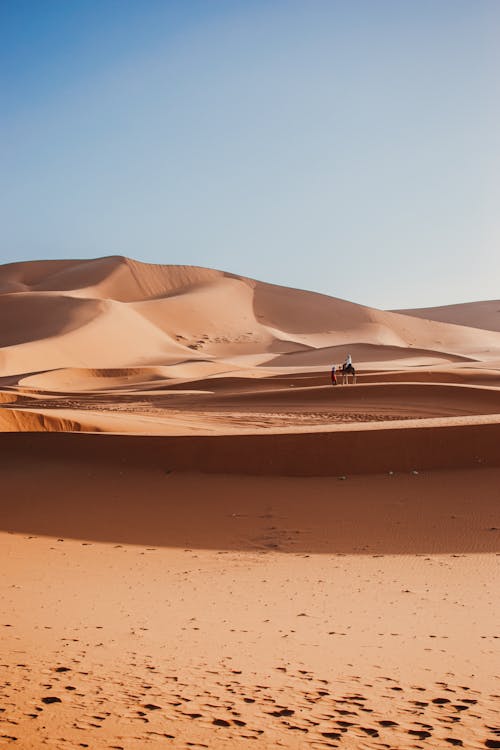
[0,456,500,555]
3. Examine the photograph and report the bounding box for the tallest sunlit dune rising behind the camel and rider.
[0,257,500,376]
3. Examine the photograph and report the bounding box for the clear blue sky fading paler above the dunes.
[0,0,500,309]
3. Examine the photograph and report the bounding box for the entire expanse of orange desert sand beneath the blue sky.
[0,257,500,750]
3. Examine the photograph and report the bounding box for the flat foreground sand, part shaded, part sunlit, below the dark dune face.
[0,468,500,748]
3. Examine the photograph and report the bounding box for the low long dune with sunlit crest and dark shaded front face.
[0,410,500,477]
